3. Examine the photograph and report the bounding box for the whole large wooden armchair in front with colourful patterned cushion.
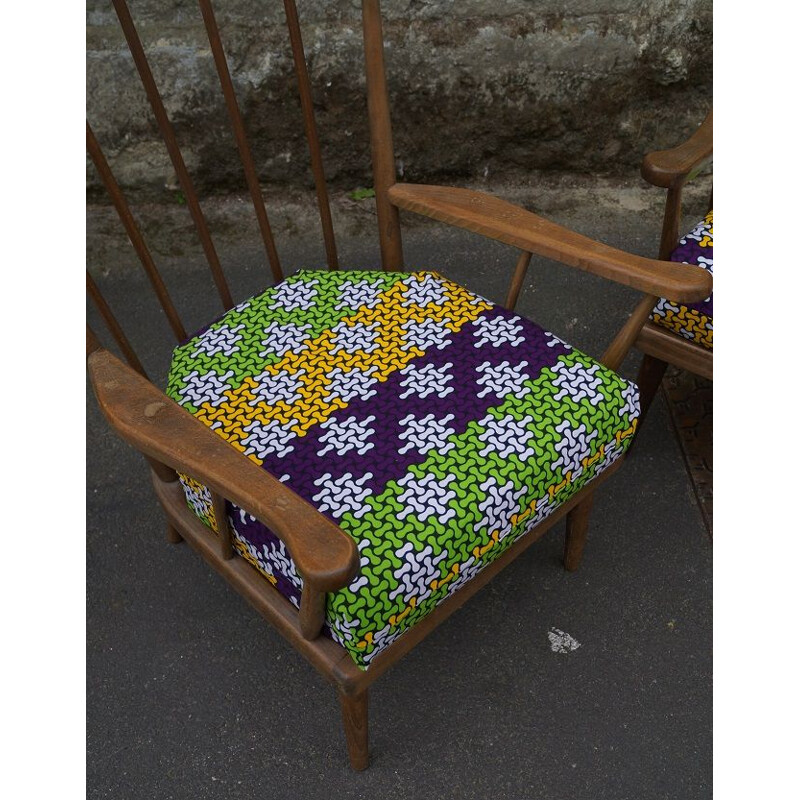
[87,0,710,769]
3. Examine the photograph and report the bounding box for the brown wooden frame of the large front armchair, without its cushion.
[87,0,711,769]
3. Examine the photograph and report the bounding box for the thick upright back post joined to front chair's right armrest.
[361,0,403,270]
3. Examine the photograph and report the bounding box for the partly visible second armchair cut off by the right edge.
[635,112,714,419]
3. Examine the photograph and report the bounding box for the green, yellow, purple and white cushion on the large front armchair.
[167,271,639,668]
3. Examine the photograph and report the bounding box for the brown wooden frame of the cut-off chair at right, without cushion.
[634,112,714,421]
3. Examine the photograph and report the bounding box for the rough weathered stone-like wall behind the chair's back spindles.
[87,0,712,194]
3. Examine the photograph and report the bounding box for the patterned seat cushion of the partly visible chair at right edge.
[652,211,714,350]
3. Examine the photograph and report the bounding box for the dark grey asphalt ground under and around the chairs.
[87,178,712,800]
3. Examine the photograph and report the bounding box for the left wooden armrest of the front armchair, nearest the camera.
[88,345,359,592]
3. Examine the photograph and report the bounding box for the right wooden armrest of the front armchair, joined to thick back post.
[389,183,712,302]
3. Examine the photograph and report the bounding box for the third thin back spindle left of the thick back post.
[112,0,233,311]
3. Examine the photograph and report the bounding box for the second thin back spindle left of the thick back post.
[199,0,283,283]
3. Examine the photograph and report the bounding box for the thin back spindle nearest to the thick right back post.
[283,0,339,269]
